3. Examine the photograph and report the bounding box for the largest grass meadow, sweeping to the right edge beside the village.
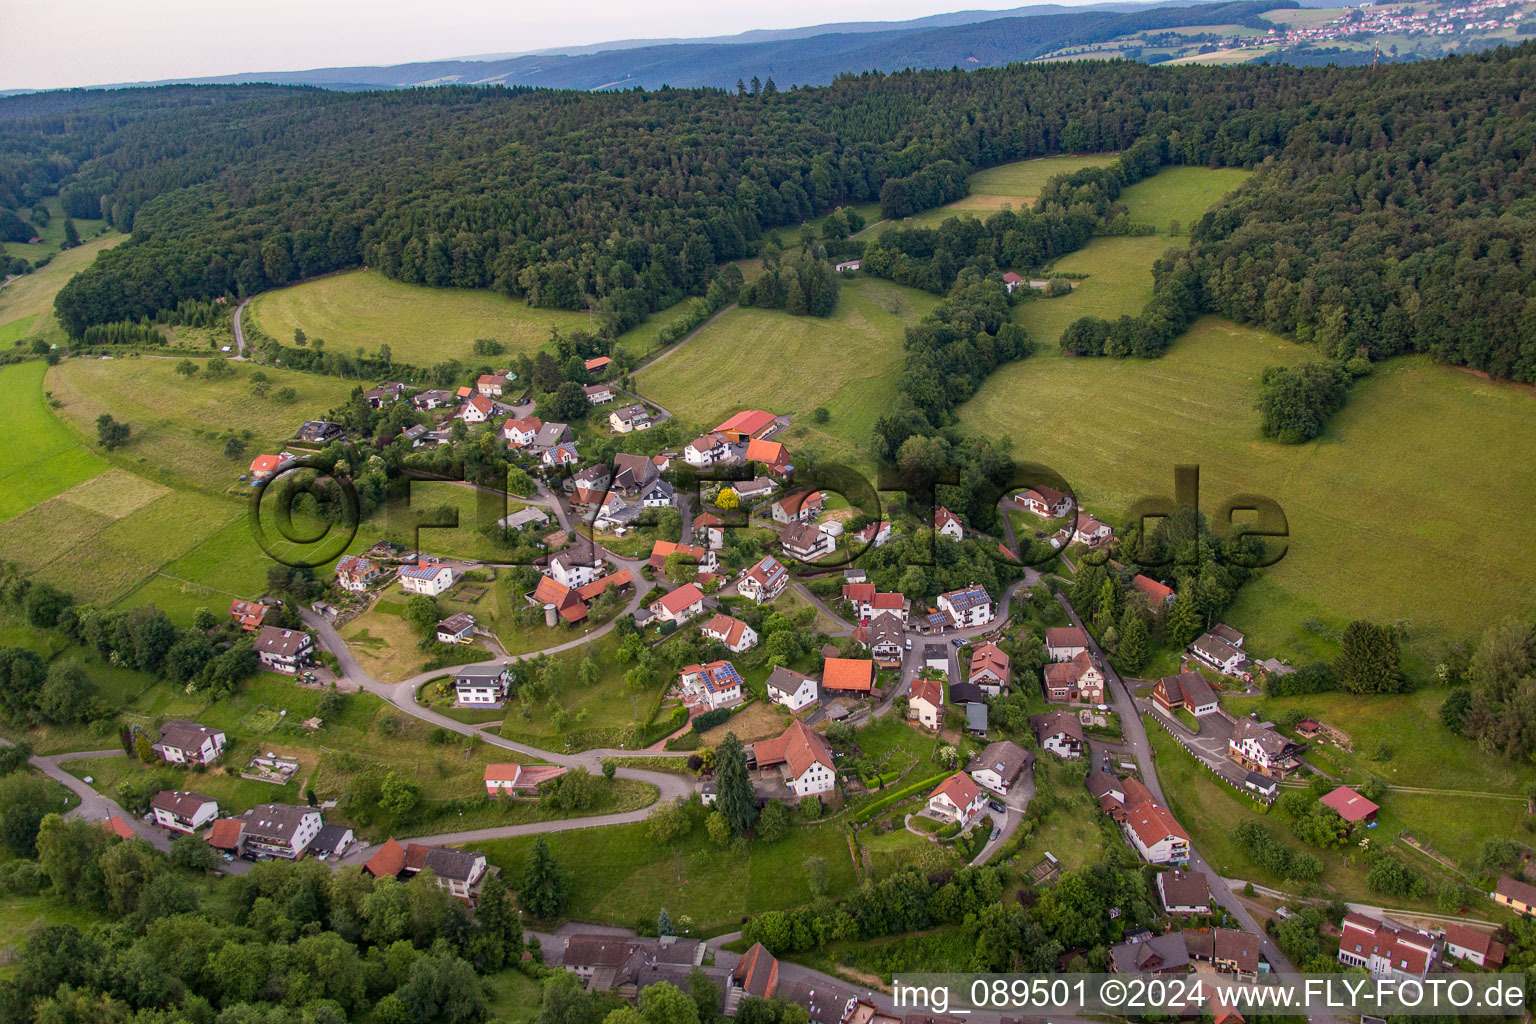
[960,316,1536,679]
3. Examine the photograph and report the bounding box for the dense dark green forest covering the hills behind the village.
[0,45,1536,389]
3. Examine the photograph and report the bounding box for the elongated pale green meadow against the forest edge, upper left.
[246,270,591,365]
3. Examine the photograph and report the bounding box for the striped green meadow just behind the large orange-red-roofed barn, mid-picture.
[634,278,937,472]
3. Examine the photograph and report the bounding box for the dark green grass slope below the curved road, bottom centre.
[475,804,854,935]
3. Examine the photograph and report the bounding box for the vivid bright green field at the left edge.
[0,360,106,522]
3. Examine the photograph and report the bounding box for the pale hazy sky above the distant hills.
[0,0,1087,89]
